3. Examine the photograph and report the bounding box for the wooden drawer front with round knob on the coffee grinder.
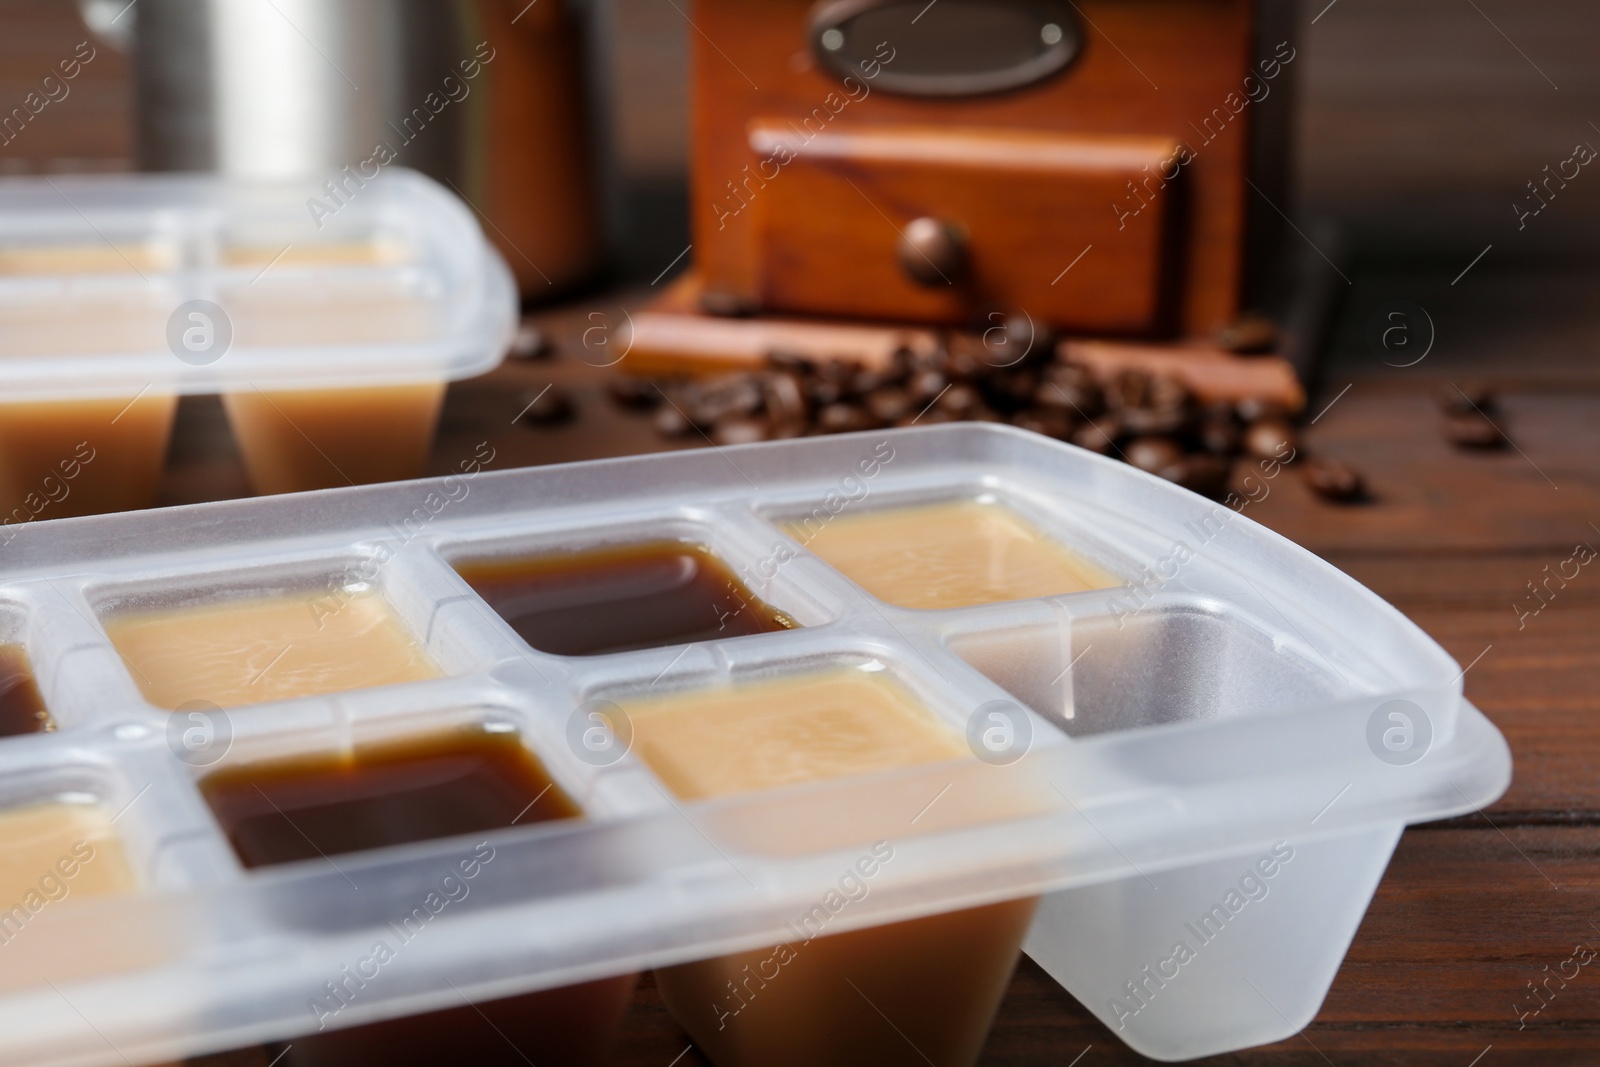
[741,120,1182,333]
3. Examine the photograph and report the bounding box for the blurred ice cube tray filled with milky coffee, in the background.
[0,168,517,505]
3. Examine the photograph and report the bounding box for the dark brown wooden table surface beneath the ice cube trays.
[147,264,1600,1067]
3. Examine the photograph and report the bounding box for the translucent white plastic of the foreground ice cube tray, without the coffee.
[0,426,1510,1067]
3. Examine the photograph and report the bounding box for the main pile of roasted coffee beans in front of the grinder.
[611,326,1365,501]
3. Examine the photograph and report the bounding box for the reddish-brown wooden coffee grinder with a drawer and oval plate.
[635,0,1299,403]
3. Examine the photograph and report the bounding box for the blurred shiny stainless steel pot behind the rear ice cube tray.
[80,0,602,296]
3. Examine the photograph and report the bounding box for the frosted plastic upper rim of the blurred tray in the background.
[0,168,517,402]
